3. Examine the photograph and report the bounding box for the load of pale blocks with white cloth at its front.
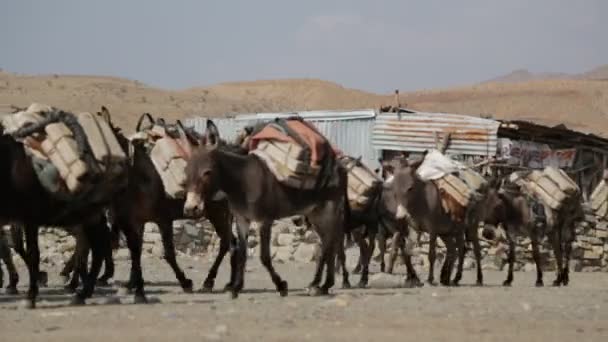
[416,150,488,224]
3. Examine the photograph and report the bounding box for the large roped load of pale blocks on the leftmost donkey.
[2,103,127,203]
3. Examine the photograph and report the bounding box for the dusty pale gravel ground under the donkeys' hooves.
[0,257,608,342]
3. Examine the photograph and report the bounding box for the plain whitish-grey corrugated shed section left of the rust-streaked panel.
[185,109,380,169]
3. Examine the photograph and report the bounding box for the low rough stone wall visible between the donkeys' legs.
[5,216,608,272]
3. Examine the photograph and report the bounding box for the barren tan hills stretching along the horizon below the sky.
[0,67,608,136]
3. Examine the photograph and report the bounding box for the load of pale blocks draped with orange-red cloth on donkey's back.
[247,117,339,190]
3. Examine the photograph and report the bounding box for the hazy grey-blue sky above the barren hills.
[0,0,608,92]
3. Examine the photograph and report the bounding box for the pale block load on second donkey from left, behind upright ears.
[129,113,199,199]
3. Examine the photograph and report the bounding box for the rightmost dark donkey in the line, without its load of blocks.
[483,180,584,287]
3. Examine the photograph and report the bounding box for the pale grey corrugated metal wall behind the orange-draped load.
[185,112,380,169]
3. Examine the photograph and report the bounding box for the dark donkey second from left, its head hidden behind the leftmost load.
[59,107,234,303]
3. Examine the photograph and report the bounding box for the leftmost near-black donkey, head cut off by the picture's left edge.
[0,110,120,308]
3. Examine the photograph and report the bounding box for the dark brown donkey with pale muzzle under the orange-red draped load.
[184,120,348,297]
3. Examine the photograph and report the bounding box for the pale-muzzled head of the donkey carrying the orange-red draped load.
[184,120,220,217]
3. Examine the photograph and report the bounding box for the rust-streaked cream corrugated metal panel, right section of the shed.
[372,110,500,157]
